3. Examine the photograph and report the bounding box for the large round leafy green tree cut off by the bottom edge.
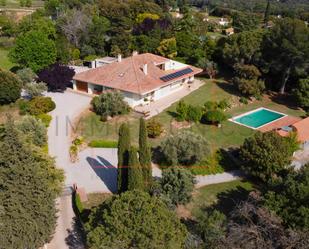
[85,191,186,249]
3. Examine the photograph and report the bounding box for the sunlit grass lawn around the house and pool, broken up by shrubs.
[76,80,304,151]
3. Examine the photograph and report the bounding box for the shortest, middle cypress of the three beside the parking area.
[128,148,144,190]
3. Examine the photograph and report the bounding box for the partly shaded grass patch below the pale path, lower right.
[186,180,254,217]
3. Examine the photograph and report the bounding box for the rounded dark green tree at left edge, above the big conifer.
[0,69,21,105]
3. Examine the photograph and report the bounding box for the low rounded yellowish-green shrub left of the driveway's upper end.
[28,97,56,115]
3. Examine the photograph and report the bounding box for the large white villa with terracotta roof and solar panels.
[73,53,202,107]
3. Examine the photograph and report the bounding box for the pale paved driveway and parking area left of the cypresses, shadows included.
[47,91,117,193]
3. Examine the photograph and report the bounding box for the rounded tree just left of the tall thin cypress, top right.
[232,12,260,32]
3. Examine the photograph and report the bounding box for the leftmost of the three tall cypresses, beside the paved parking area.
[117,123,131,193]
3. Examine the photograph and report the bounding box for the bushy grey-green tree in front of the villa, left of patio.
[91,91,130,119]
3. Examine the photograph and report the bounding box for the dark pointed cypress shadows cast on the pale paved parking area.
[86,156,117,193]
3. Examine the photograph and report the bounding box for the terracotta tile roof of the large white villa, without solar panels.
[73,53,202,94]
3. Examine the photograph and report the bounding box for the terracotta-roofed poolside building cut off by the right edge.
[277,117,309,149]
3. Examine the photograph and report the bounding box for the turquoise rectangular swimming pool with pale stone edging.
[230,107,286,129]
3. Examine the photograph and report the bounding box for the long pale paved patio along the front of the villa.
[134,79,204,119]
